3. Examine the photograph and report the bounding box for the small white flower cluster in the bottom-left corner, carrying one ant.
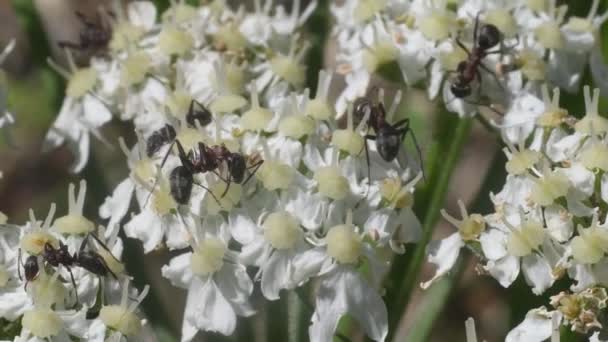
[0,181,148,342]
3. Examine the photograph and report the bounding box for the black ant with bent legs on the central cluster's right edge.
[353,92,424,182]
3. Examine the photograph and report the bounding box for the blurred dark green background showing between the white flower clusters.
[0,0,608,341]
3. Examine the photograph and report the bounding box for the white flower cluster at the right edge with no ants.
[423,86,608,341]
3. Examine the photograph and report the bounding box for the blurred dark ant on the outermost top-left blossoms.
[58,11,112,53]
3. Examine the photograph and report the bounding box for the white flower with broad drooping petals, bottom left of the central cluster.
[162,217,254,341]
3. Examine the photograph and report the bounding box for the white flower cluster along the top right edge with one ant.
[331,0,608,127]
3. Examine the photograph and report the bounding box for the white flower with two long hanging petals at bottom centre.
[294,212,388,341]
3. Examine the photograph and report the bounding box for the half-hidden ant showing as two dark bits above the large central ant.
[146,100,212,157]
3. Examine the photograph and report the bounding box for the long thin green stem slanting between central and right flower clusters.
[387,118,473,341]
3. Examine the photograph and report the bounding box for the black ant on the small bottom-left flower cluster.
[17,233,118,301]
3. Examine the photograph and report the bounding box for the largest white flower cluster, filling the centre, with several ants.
[38,1,422,341]
